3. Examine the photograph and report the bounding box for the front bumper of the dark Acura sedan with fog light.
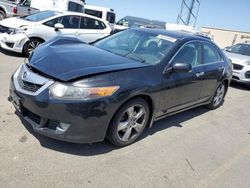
[9,64,118,143]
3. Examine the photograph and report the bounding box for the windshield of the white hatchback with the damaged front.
[21,11,60,22]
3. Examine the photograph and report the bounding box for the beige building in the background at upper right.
[201,27,250,48]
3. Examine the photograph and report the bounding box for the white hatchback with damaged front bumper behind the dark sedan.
[0,11,112,56]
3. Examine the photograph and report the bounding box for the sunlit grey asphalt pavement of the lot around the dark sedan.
[0,51,250,188]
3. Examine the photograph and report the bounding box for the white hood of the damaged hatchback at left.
[0,17,36,29]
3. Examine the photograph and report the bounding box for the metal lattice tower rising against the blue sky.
[177,0,201,27]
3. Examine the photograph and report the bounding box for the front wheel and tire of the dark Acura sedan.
[107,98,150,147]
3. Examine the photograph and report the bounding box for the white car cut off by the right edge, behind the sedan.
[225,42,250,86]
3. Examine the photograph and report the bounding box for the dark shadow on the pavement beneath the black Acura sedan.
[16,107,209,156]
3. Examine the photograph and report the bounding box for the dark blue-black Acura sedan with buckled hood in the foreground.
[9,29,232,146]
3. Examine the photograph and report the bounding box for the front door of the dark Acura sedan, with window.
[158,42,203,114]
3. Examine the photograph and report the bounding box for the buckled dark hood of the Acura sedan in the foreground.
[29,37,150,81]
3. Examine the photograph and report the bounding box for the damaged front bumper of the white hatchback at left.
[0,33,29,53]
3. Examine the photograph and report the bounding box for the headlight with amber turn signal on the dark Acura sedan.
[50,83,120,100]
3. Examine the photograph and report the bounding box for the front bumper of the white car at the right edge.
[232,64,250,85]
